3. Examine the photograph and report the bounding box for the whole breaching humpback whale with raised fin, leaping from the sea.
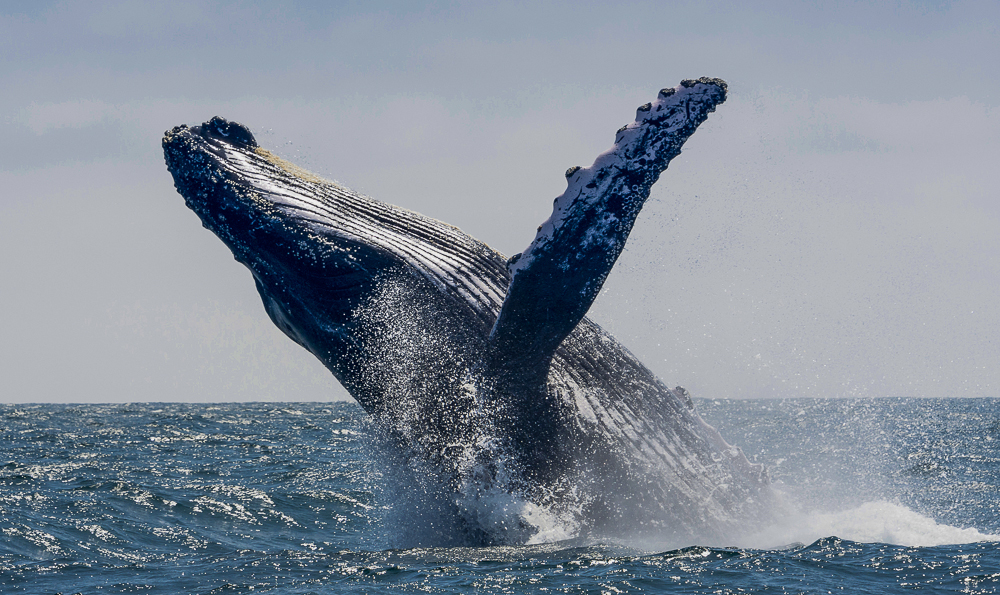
[163,78,770,544]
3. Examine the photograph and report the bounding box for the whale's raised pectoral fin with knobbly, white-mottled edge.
[482,78,726,384]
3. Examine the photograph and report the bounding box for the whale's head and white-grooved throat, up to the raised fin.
[163,117,509,400]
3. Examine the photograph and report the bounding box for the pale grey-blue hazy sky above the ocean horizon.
[0,0,1000,403]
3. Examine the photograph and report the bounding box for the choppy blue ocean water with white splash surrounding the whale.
[0,399,1000,594]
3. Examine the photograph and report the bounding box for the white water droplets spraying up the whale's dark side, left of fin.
[355,280,580,546]
